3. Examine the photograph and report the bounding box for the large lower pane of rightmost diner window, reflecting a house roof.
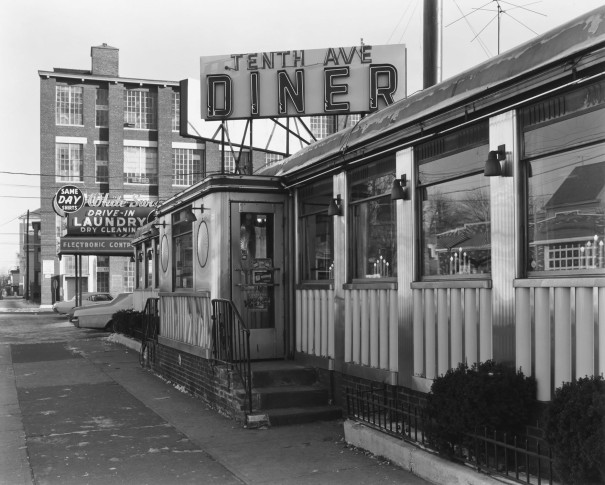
[528,144,605,271]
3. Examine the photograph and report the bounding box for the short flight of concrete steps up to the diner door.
[244,361,342,426]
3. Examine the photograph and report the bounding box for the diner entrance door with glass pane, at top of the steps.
[231,202,284,360]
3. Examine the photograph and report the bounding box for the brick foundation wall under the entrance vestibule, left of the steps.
[152,345,245,422]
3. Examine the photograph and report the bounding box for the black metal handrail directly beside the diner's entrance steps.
[212,298,252,414]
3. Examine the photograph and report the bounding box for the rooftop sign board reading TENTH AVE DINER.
[200,45,406,120]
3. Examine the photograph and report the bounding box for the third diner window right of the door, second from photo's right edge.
[414,122,491,278]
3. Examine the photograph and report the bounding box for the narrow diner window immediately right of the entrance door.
[299,178,334,281]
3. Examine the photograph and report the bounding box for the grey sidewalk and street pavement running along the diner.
[0,300,427,485]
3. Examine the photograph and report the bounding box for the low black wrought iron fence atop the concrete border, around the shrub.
[346,386,554,485]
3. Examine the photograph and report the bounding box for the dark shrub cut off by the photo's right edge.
[544,376,605,484]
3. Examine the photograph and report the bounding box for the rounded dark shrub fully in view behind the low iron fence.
[426,360,536,455]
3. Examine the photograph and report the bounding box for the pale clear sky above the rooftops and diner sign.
[0,0,603,275]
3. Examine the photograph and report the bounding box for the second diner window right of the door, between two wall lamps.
[350,156,397,280]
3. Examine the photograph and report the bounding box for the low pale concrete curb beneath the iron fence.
[343,420,503,485]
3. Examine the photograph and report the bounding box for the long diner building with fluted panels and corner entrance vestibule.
[135,8,605,424]
